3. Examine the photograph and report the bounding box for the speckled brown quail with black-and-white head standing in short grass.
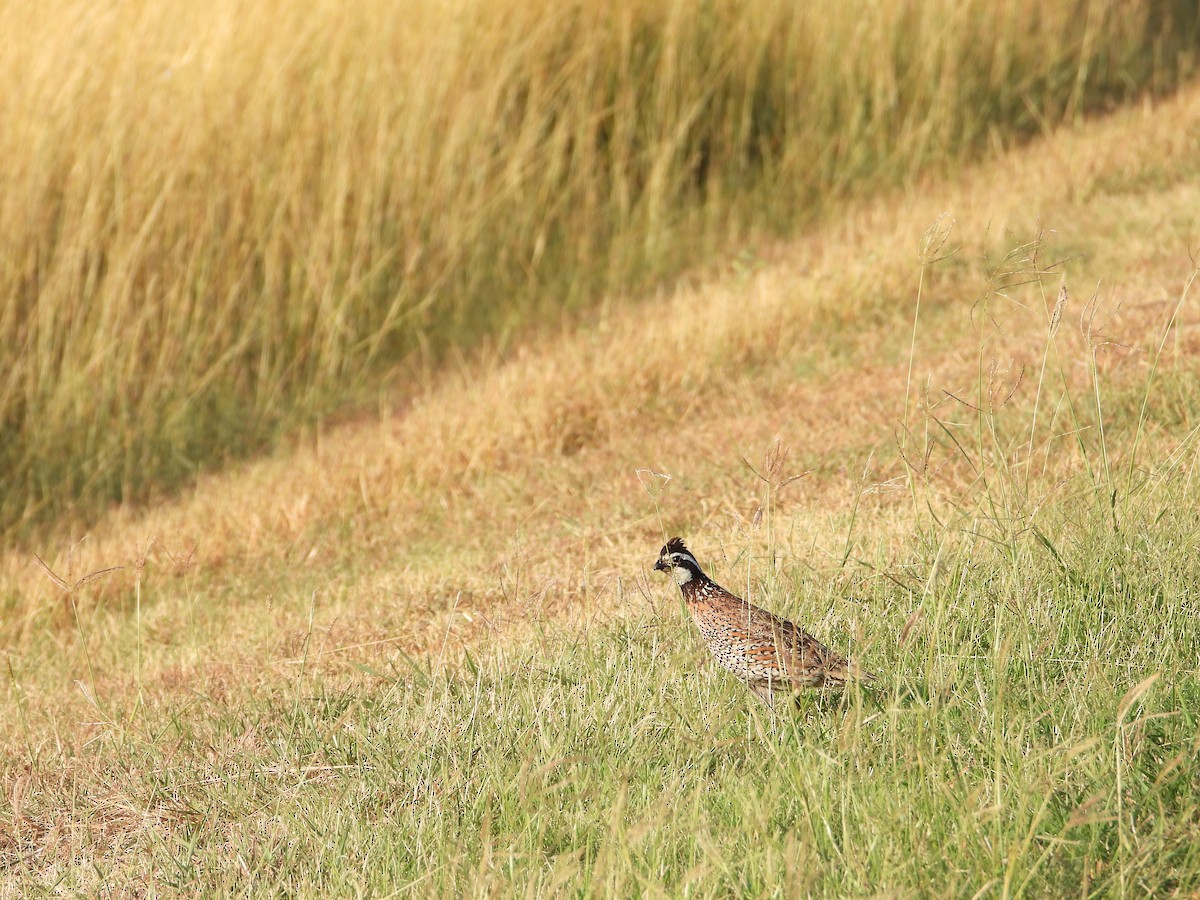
[654,538,875,707]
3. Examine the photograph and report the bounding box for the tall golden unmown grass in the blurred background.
[0,0,1196,538]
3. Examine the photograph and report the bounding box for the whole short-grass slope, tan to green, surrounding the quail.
[0,77,1200,896]
